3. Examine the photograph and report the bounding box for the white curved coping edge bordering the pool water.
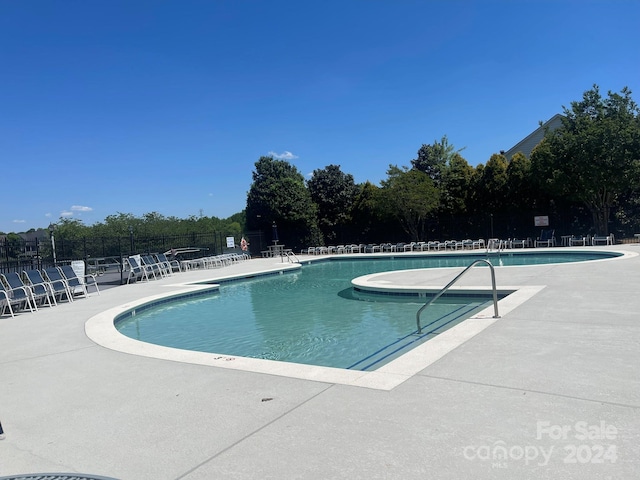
[85,247,638,390]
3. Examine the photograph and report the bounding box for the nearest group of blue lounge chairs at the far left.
[0,265,100,317]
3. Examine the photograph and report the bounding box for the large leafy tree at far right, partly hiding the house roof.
[531,85,640,234]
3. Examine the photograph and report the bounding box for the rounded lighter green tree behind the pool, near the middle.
[382,165,439,241]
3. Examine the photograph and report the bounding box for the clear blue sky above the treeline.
[0,0,640,232]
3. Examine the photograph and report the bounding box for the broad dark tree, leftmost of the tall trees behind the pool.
[246,157,322,248]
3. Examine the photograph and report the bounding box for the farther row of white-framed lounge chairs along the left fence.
[126,249,250,283]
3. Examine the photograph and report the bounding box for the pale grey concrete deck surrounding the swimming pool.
[0,244,640,480]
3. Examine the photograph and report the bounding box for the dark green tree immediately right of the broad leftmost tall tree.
[307,165,358,243]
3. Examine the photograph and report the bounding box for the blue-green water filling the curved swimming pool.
[116,252,612,370]
